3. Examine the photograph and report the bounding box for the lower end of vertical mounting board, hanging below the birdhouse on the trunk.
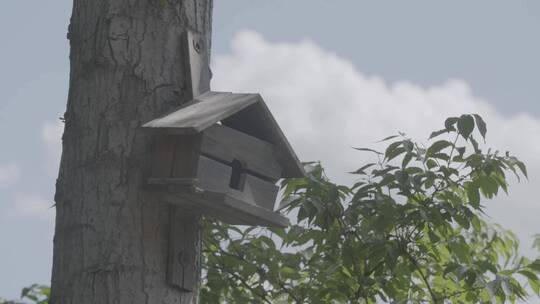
[167,206,201,292]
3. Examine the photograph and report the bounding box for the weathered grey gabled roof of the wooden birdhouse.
[143,92,305,178]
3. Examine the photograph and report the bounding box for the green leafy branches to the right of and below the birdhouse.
[201,115,540,303]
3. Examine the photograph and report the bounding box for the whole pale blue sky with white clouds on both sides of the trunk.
[0,0,540,298]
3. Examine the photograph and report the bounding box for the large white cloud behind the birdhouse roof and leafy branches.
[213,31,540,253]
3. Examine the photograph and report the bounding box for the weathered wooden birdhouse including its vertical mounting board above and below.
[142,31,304,292]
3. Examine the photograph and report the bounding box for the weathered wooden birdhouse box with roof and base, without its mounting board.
[143,92,303,227]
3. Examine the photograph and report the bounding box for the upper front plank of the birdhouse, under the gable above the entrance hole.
[201,125,282,180]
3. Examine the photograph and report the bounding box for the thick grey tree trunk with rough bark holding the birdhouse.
[51,0,212,304]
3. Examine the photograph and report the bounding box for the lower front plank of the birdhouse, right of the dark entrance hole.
[229,174,279,211]
